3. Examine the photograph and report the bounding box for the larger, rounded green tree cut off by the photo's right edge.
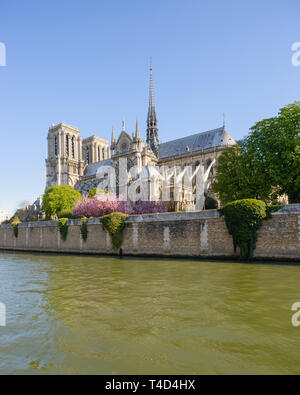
[245,102,300,203]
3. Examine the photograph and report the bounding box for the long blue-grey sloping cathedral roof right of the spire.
[159,126,236,159]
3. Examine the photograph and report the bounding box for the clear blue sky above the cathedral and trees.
[0,0,300,215]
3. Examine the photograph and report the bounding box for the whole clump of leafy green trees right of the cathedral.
[213,102,300,203]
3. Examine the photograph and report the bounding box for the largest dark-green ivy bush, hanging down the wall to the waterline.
[219,199,267,260]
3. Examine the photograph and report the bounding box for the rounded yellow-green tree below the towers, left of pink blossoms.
[42,185,81,219]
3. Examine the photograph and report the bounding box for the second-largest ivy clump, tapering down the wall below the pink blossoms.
[100,213,129,251]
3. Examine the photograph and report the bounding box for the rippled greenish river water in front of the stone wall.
[0,253,300,374]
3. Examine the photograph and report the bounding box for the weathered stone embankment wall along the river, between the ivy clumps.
[0,204,300,261]
